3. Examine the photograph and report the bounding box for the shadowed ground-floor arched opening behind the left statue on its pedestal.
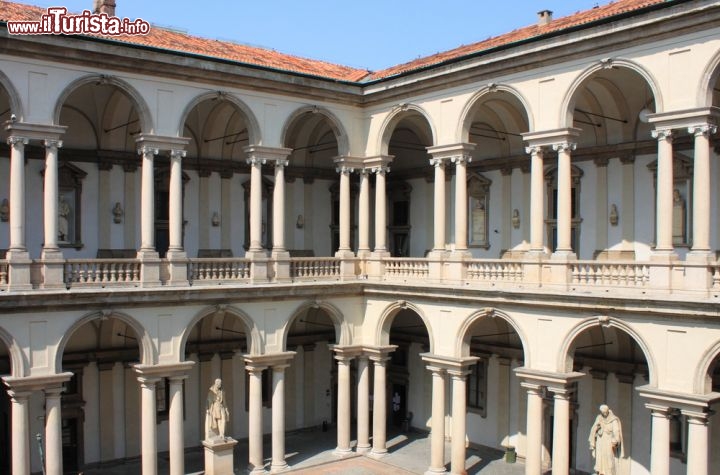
[182,306,252,441]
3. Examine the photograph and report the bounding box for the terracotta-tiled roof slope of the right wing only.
[365,0,668,81]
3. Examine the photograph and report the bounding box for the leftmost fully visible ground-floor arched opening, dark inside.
[62,315,141,473]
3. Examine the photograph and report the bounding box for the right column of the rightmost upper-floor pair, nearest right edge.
[688,124,717,254]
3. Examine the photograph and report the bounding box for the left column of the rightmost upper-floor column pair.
[652,129,674,254]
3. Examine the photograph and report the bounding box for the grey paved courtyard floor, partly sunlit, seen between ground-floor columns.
[82,430,525,475]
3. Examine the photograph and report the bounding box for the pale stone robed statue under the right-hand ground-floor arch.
[588,404,625,475]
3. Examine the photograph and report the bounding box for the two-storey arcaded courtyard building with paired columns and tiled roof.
[0,0,720,475]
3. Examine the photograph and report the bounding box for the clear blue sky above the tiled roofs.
[23,0,608,70]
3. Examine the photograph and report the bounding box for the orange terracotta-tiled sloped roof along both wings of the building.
[0,0,674,82]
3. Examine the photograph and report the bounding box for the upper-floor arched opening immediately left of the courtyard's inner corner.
[283,108,344,255]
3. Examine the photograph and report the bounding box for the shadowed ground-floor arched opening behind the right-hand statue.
[564,323,648,473]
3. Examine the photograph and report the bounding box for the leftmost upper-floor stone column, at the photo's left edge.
[8,137,28,251]
